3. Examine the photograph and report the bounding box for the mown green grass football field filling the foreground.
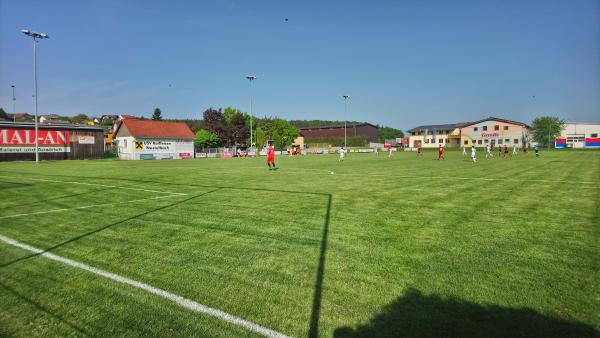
[0,151,600,337]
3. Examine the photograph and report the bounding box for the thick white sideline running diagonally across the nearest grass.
[0,235,289,338]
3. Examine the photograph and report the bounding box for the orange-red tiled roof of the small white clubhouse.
[115,119,196,139]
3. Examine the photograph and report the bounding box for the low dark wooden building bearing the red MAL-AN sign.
[0,121,104,161]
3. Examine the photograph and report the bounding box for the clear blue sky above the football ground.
[0,0,600,129]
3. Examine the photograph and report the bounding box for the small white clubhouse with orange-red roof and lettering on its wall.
[114,118,195,160]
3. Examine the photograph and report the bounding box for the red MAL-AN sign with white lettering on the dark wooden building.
[0,129,71,153]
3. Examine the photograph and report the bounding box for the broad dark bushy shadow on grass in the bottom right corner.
[334,289,600,338]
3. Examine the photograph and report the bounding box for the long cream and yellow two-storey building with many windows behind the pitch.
[408,117,531,148]
